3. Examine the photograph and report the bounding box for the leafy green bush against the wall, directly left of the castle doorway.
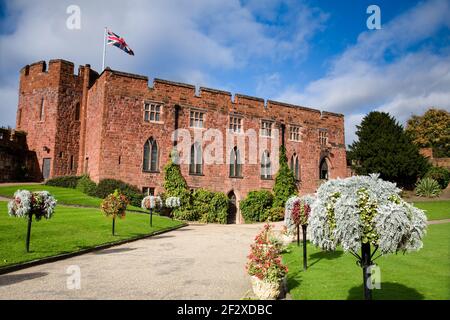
[192,189,228,224]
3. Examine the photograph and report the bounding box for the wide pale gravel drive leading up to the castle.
[0,224,282,300]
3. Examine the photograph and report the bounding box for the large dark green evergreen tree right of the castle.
[349,111,429,189]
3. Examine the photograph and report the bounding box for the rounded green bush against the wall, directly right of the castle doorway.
[239,190,273,222]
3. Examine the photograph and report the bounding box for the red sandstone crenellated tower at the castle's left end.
[16,59,95,179]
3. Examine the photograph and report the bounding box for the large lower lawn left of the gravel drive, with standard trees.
[0,201,181,267]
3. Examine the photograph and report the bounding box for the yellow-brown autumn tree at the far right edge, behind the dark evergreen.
[406,108,450,158]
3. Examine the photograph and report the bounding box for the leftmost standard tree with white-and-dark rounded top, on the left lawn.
[8,190,56,252]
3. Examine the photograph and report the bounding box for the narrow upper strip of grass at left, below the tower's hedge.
[0,184,143,211]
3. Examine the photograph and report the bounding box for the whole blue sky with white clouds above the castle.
[0,0,450,144]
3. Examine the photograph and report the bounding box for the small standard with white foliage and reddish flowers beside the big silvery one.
[284,195,315,270]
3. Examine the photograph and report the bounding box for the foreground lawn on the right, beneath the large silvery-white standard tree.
[283,223,450,300]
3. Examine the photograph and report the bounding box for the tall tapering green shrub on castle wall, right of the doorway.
[273,146,297,208]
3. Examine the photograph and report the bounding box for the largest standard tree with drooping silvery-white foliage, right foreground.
[309,174,427,299]
